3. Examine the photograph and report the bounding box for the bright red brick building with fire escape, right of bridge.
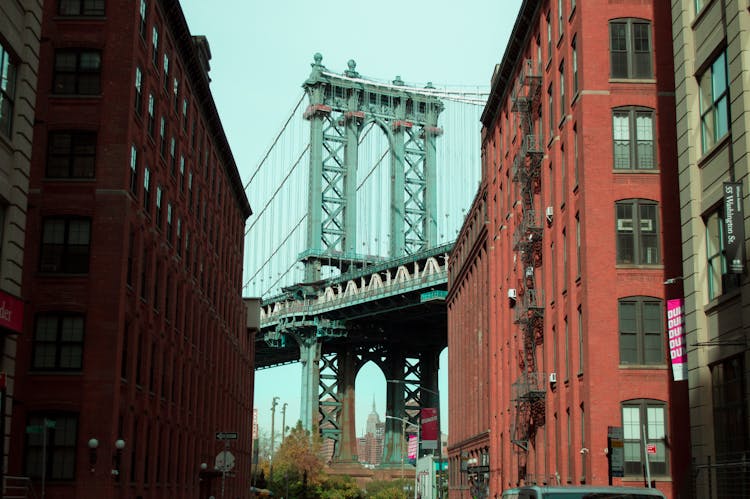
[449,0,690,497]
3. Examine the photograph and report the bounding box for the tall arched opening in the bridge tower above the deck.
[356,120,393,261]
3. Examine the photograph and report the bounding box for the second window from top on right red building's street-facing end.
[612,108,656,170]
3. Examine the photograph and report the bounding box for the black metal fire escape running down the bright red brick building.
[511,59,546,481]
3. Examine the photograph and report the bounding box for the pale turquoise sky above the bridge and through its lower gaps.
[181,0,521,442]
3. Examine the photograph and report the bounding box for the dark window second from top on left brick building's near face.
[52,49,102,95]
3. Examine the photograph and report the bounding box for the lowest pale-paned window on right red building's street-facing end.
[622,400,669,477]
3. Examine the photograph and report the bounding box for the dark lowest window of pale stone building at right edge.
[711,356,750,458]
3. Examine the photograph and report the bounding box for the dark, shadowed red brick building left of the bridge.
[9,0,253,499]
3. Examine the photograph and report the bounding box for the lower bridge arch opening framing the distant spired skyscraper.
[354,361,386,466]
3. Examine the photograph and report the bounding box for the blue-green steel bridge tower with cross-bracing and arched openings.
[283,54,444,466]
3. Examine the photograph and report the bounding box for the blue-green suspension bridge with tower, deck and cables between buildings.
[243,54,487,472]
